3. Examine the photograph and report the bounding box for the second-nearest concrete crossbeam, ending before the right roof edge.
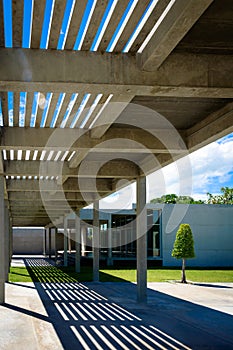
[0,123,186,152]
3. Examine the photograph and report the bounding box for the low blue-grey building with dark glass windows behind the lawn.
[13,204,233,267]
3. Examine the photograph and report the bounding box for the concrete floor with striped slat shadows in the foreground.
[0,258,233,350]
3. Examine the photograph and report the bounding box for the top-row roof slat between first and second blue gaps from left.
[12,0,24,47]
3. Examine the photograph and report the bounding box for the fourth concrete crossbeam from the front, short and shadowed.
[7,179,112,193]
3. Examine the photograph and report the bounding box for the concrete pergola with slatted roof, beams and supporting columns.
[0,0,233,303]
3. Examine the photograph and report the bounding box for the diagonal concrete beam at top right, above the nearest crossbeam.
[137,0,213,71]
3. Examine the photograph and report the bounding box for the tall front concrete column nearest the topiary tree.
[136,176,147,303]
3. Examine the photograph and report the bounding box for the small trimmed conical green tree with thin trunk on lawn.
[172,224,195,283]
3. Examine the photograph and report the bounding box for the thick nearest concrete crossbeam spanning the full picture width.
[0,48,233,98]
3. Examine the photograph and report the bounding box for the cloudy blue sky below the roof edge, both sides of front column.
[101,133,233,209]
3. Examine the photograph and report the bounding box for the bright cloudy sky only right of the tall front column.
[149,135,233,199]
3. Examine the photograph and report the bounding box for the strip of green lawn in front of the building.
[9,266,233,282]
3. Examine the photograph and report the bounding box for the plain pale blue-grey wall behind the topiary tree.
[162,204,233,267]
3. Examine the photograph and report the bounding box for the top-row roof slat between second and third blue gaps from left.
[31,0,46,49]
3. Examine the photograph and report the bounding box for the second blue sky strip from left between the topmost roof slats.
[22,0,34,49]
